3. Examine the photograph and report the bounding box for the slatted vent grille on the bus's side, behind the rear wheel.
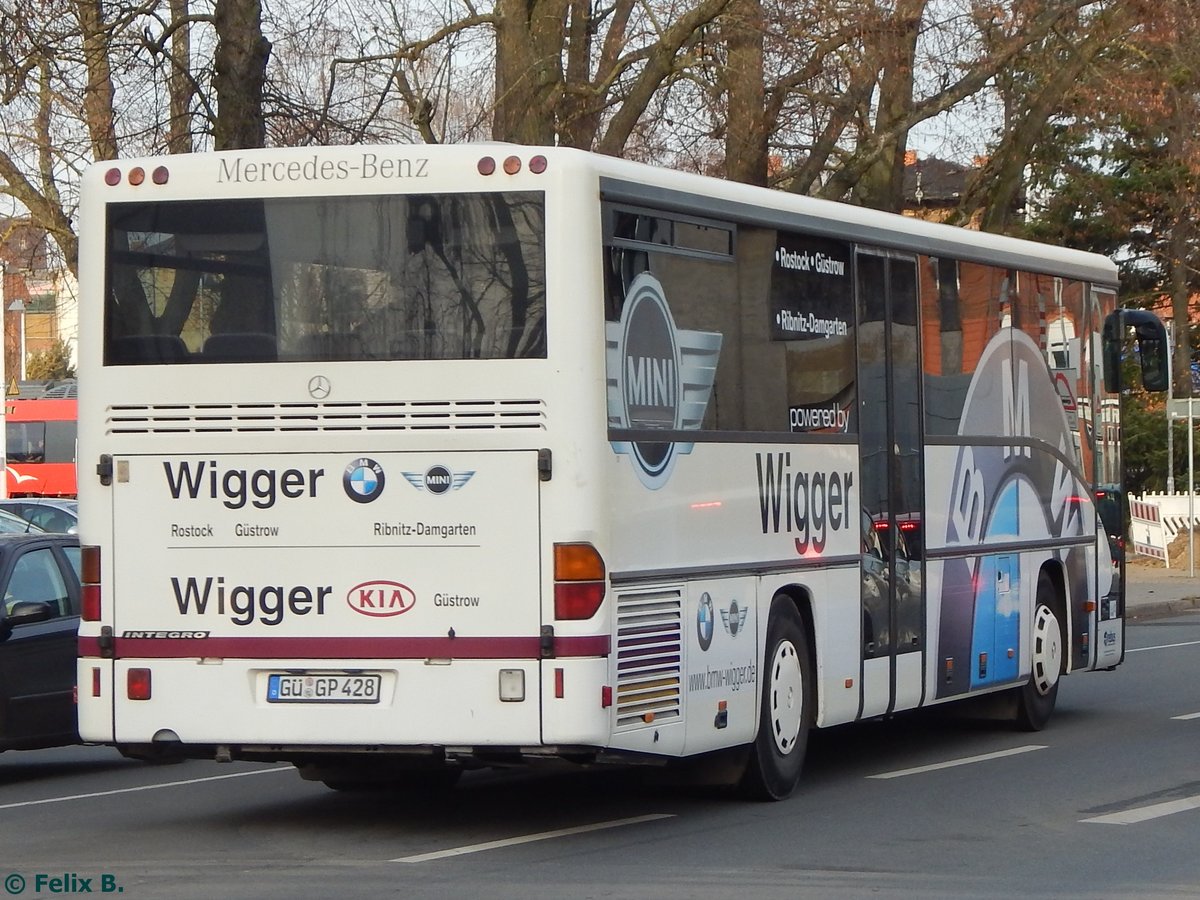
[617,590,683,731]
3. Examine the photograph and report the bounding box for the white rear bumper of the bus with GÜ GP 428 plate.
[94,658,610,758]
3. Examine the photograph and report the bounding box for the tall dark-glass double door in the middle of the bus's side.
[856,248,925,718]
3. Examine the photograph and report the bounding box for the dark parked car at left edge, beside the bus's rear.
[0,533,79,750]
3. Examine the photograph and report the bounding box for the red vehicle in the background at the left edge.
[5,397,78,497]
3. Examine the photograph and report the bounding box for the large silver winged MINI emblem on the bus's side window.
[605,272,722,491]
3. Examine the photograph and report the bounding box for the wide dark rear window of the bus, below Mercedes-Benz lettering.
[104,192,546,366]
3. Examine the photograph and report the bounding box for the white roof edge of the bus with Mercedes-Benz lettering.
[83,143,1117,287]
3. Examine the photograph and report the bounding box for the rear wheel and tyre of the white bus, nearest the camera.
[742,594,814,800]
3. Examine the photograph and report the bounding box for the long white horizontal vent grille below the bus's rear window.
[108,400,546,434]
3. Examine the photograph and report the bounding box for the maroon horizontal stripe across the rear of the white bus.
[79,635,612,660]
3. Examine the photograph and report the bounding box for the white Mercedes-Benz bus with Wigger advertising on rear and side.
[78,145,1165,798]
